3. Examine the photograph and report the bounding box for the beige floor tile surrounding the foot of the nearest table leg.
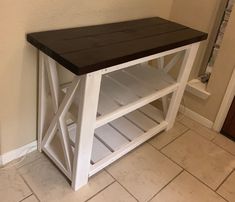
[19,158,114,202]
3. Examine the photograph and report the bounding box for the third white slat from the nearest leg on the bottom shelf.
[110,117,144,140]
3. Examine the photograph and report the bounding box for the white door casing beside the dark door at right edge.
[213,69,235,132]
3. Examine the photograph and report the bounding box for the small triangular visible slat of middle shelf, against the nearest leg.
[98,91,120,115]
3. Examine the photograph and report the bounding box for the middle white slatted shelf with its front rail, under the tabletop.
[96,63,178,128]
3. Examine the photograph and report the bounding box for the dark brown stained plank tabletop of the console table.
[27,17,207,75]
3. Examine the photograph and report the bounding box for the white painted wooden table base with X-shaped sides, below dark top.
[38,43,199,190]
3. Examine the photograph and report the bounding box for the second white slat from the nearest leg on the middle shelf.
[101,76,139,105]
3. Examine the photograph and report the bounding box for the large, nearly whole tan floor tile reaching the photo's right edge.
[162,131,235,189]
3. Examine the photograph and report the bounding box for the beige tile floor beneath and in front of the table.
[0,117,235,202]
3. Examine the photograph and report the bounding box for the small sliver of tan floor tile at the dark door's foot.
[213,134,235,155]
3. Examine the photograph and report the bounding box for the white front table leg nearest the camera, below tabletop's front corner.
[72,71,101,190]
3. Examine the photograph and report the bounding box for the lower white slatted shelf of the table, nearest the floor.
[68,104,164,167]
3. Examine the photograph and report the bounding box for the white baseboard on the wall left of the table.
[0,141,37,166]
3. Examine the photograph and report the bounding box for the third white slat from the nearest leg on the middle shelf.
[109,71,155,97]
